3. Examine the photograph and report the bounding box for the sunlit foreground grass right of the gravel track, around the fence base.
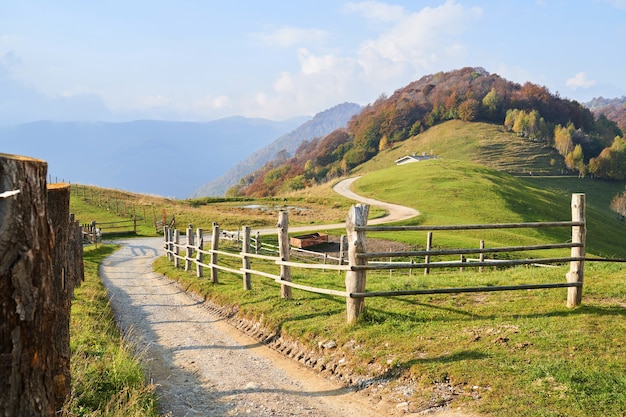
[155,242,626,417]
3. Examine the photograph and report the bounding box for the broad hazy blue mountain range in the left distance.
[0,116,309,198]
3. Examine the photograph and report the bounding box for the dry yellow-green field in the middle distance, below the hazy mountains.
[66,184,358,236]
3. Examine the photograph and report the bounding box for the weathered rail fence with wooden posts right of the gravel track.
[164,194,586,323]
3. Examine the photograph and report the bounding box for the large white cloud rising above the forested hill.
[234,1,482,118]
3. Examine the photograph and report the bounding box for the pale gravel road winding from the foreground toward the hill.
[100,180,472,417]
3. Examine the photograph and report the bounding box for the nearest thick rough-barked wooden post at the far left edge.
[0,154,57,417]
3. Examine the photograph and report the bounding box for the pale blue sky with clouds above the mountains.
[0,0,626,124]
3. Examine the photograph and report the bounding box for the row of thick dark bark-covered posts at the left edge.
[0,154,83,417]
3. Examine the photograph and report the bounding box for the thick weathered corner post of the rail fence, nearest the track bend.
[346,204,369,324]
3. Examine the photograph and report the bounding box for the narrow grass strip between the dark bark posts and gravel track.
[62,245,158,417]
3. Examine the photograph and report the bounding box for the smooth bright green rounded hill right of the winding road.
[354,158,626,258]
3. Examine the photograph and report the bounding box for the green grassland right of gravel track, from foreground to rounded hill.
[72,135,626,417]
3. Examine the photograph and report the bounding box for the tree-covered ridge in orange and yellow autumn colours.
[227,68,626,197]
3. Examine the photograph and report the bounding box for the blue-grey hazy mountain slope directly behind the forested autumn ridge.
[192,103,362,197]
